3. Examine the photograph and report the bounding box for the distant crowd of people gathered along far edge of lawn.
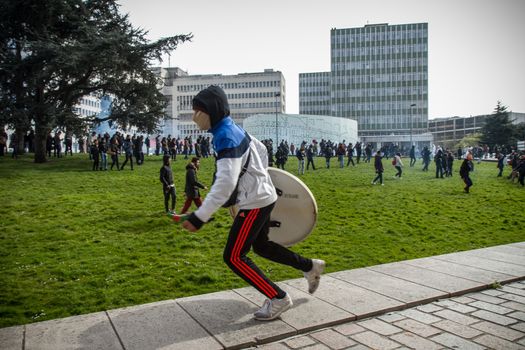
[0,129,525,190]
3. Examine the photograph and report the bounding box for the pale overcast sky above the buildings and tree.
[120,0,525,119]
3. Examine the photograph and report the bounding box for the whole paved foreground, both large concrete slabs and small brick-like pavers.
[0,242,525,350]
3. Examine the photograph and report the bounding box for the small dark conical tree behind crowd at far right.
[480,101,515,147]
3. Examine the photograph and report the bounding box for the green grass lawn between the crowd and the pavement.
[0,155,525,327]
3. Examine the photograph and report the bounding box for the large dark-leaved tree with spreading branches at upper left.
[0,0,192,162]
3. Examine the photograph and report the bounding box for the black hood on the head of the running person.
[189,85,230,127]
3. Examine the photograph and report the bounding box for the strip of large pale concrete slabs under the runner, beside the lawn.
[0,242,525,350]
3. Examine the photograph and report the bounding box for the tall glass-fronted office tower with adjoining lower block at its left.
[299,23,431,143]
